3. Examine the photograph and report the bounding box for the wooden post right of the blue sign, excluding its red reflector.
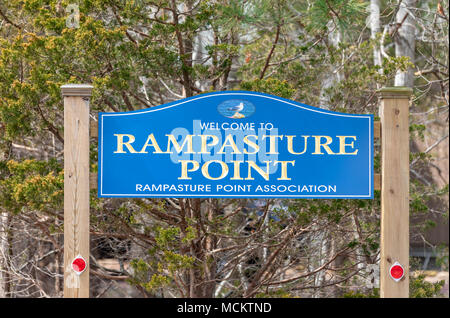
[379,87,412,298]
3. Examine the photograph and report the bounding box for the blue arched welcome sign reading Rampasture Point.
[98,91,373,199]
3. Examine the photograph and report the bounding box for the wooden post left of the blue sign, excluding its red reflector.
[61,84,92,298]
